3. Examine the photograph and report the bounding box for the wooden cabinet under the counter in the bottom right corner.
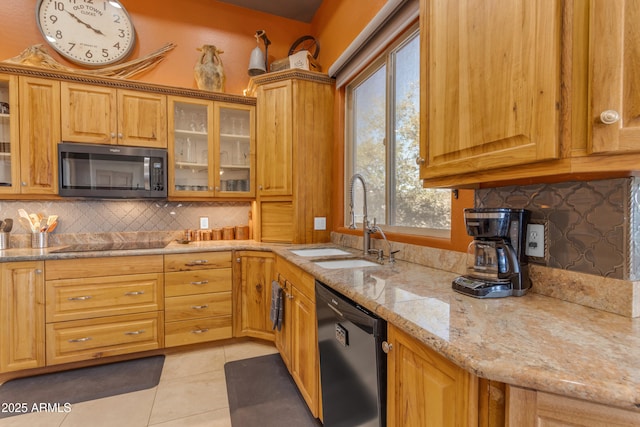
[506,386,640,427]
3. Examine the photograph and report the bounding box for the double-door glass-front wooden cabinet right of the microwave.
[168,97,255,198]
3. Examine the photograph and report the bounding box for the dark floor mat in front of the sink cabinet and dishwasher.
[224,354,322,427]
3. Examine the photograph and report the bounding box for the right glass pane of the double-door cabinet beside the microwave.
[220,108,251,193]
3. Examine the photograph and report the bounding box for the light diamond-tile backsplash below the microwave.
[0,200,251,234]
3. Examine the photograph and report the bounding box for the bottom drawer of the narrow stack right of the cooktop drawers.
[164,316,232,347]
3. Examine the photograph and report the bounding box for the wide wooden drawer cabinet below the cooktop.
[45,255,164,365]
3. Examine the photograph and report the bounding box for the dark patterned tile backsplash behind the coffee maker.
[475,178,640,280]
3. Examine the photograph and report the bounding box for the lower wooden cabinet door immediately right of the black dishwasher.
[387,324,478,427]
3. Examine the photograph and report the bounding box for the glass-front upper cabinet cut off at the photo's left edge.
[0,74,20,193]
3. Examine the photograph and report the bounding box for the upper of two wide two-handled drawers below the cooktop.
[45,274,164,323]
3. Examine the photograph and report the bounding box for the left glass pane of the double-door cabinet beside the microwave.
[173,102,211,192]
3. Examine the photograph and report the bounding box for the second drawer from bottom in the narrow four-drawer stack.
[164,292,231,322]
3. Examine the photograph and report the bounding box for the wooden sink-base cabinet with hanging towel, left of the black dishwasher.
[276,257,320,417]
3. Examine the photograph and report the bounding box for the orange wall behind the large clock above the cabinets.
[0,0,312,94]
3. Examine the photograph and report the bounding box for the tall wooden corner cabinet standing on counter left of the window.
[249,69,335,243]
